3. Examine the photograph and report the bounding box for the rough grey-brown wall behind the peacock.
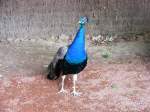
[0,0,150,38]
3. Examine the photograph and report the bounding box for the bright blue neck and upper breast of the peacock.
[65,25,86,64]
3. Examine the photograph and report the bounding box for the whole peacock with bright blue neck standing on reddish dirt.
[47,16,88,96]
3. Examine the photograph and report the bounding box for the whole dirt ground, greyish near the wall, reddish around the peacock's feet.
[0,43,150,112]
